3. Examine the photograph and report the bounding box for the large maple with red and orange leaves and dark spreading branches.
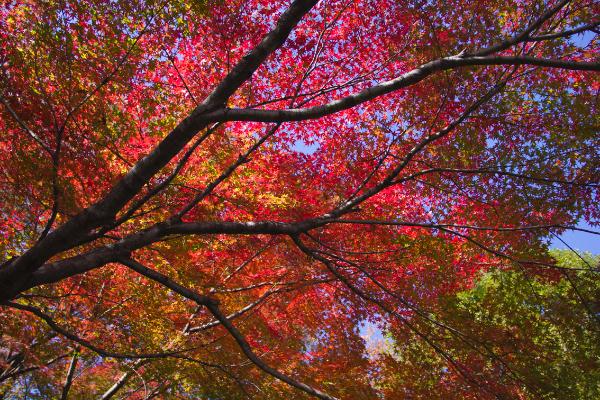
[0,0,600,399]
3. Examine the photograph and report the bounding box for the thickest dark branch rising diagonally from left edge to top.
[0,0,317,297]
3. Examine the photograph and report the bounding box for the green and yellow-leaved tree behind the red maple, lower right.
[377,251,600,399]
